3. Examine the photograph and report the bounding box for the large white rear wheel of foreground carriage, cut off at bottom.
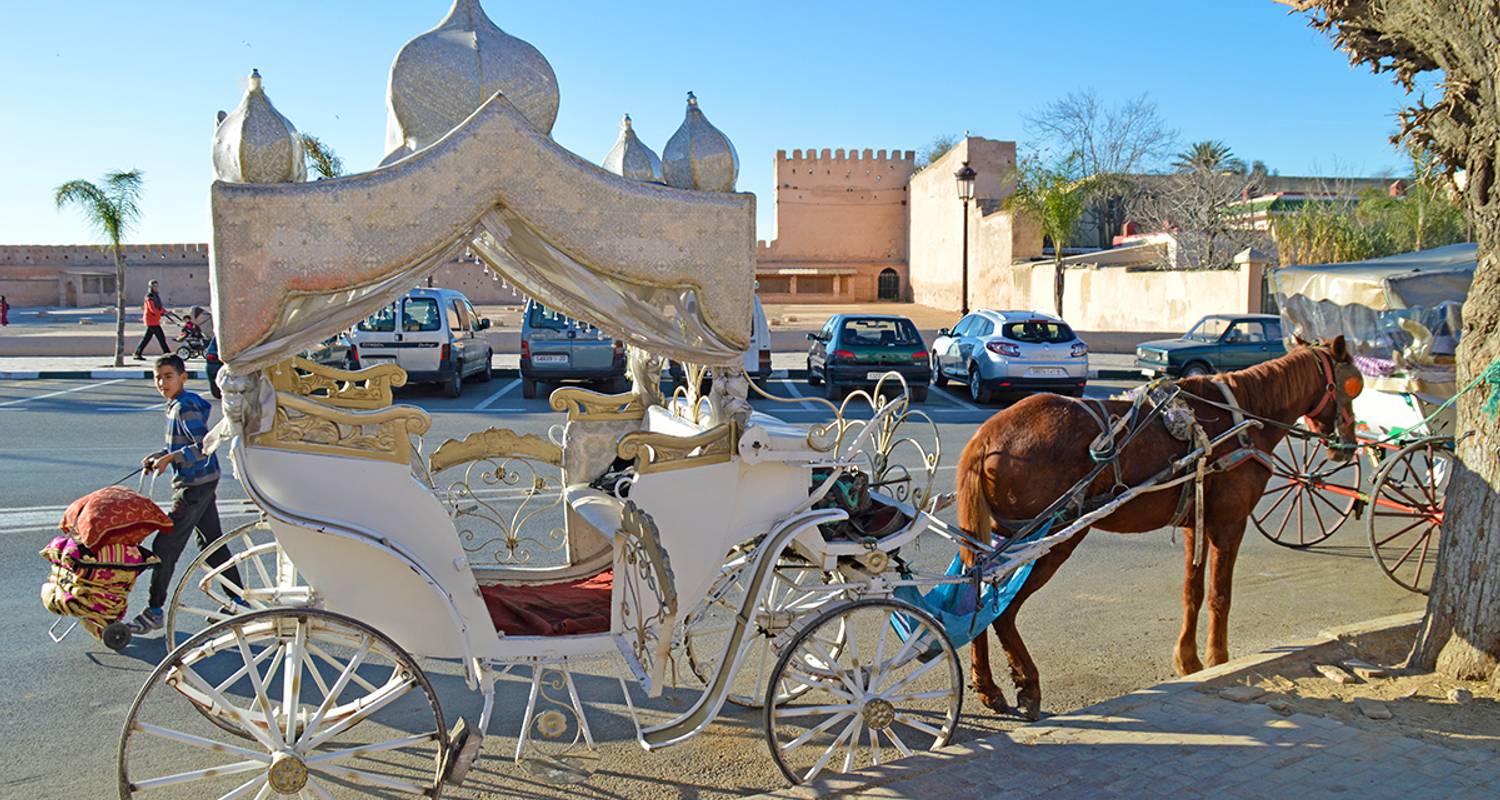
[117,609,449,798]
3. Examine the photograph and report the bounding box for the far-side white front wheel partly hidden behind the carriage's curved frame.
[684,555,845,708]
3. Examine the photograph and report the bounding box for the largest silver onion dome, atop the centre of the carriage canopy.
[381,0,558,164]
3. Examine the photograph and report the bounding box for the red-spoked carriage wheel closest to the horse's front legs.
[1250,437,1365,549]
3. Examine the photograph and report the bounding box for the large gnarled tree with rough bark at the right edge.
[1280,0,1500,680]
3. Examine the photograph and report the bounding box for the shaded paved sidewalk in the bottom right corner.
[762,612,1500,800]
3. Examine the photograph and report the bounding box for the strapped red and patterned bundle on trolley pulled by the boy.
[41,486,173,651]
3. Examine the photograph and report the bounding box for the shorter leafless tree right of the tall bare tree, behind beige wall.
[1130,167,1271,269]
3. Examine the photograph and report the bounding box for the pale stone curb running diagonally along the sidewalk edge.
[750,611,1424,800]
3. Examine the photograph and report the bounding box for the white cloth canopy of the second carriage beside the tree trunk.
[1271,245,1478,375]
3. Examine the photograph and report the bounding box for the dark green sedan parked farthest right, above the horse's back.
[1136,314,1287,377]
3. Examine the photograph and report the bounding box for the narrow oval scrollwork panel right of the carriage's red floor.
[615,501,677,696]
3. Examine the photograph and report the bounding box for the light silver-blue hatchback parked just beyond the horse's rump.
[932,309,1089,402]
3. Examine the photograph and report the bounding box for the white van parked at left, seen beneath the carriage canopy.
[350,288,494,398]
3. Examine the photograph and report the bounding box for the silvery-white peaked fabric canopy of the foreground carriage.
[210,93,755,371]
